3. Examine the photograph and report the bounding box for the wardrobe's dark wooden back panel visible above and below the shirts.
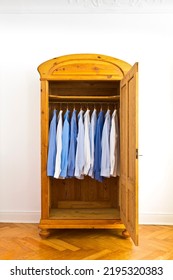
[49,81,120,208]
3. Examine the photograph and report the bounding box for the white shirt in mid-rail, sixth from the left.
[84,109,91,175]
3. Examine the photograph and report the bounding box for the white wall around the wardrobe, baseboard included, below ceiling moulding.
[0,14,173,224]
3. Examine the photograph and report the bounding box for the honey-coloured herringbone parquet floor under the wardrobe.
[0,223,173,260]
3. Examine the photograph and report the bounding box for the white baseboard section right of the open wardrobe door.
[139,213,173,225]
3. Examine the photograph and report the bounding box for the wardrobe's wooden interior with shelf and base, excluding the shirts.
[48,80,120,220]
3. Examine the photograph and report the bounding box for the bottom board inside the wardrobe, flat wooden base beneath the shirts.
[49,208,120,220]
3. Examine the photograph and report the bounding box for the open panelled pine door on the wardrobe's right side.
[120,63,138,245]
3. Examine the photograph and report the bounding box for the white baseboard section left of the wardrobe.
[0,211,41,223]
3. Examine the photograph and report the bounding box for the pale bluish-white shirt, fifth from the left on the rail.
[74,110,85,179]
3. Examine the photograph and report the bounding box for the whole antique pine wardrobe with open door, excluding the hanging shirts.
[38,54,138,245]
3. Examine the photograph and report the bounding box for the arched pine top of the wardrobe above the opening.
[38,54,132,81]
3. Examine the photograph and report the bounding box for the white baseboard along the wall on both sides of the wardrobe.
[0,211,173,225]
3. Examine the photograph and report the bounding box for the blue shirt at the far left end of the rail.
[47,110,57,176]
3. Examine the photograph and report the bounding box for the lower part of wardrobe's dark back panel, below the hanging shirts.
[50,176,119,208]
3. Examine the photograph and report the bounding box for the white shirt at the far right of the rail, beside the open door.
[110,110,120,177]
